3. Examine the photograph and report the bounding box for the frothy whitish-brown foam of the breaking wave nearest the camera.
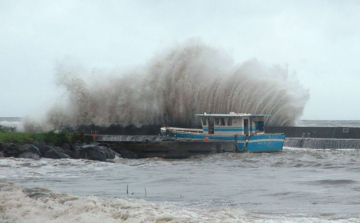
[0,180,359,223]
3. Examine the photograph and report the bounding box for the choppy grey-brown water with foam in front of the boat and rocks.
[0,148,360,222]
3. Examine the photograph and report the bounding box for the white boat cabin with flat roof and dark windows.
[196,112,271,135]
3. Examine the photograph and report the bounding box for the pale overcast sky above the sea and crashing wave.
[0,0,360,120]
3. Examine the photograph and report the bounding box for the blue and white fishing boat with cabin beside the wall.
[160,112,285,152]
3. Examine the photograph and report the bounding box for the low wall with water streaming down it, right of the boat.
[284,138,360,149]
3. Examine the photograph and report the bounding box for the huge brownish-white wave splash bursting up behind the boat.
[47,41,309,128]
